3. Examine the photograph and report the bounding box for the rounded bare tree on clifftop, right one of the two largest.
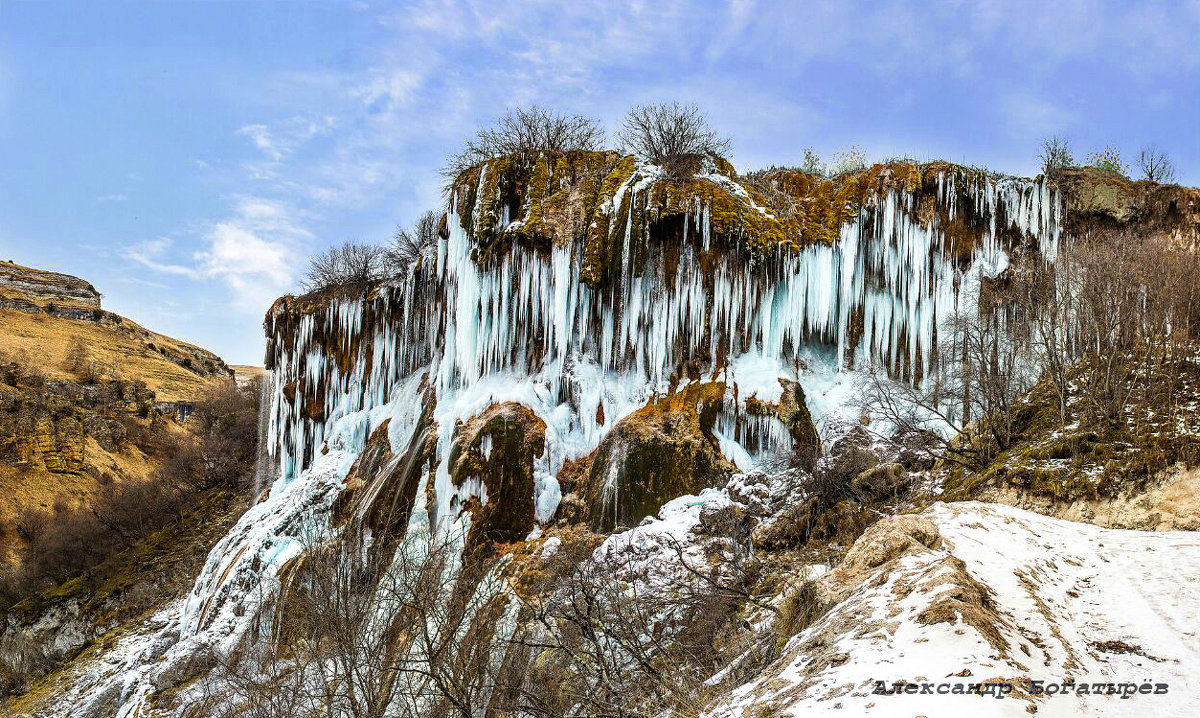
[620,102,730,178]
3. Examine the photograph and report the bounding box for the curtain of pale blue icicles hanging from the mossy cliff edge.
[268,166,1063,501]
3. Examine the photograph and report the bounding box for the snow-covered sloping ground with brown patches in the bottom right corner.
[712,502,1200,718]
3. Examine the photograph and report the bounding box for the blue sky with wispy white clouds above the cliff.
[0,0,1200,364]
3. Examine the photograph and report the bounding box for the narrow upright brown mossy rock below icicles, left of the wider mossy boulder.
[450,402,546,546]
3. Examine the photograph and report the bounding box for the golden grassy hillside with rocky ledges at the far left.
[0,262,233,537]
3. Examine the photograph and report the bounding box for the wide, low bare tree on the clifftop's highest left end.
[443,104,605,183]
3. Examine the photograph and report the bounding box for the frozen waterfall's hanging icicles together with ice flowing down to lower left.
[68,165,1063,718]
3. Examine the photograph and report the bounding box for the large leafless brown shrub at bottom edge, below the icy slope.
[205,523,505,718]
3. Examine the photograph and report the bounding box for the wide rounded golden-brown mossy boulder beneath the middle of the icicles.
[586,383,737,531]
